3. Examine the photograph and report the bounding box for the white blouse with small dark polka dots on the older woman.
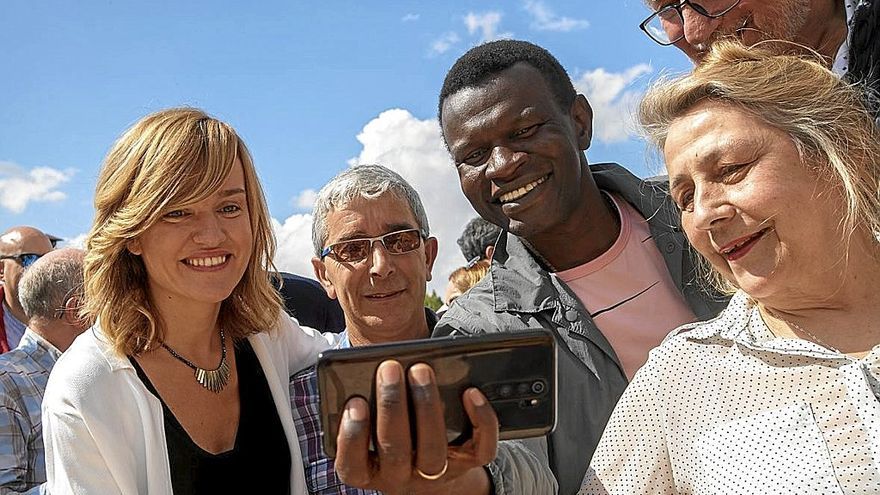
[580,293,880,494]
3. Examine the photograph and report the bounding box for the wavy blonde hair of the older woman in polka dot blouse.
[639,40,880,293]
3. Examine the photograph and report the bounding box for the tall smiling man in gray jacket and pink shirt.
[434,40,724,493]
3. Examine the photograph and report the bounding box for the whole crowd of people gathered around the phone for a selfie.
[0,0,880,495]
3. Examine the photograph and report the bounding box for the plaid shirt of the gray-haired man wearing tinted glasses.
[290,332,381,495]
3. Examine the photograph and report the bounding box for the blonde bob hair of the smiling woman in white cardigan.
[84,108,281,355]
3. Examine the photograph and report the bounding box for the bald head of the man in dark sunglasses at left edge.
[0,225,52,322]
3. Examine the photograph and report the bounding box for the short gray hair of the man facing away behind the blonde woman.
[18,249,83,320]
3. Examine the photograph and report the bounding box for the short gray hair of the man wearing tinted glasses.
[312,165,431,256]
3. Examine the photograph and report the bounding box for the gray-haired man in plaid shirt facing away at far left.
[0,248,88,495]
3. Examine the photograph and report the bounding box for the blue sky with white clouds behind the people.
[0,0,689,292]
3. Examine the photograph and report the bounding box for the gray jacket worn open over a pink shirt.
[434,164,727,494]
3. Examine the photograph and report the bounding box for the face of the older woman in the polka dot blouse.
[663,102,847,299]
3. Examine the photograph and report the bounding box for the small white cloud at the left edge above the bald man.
[0,161,74,213]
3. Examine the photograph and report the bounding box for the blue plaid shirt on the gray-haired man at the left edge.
[0,330,61,494]
